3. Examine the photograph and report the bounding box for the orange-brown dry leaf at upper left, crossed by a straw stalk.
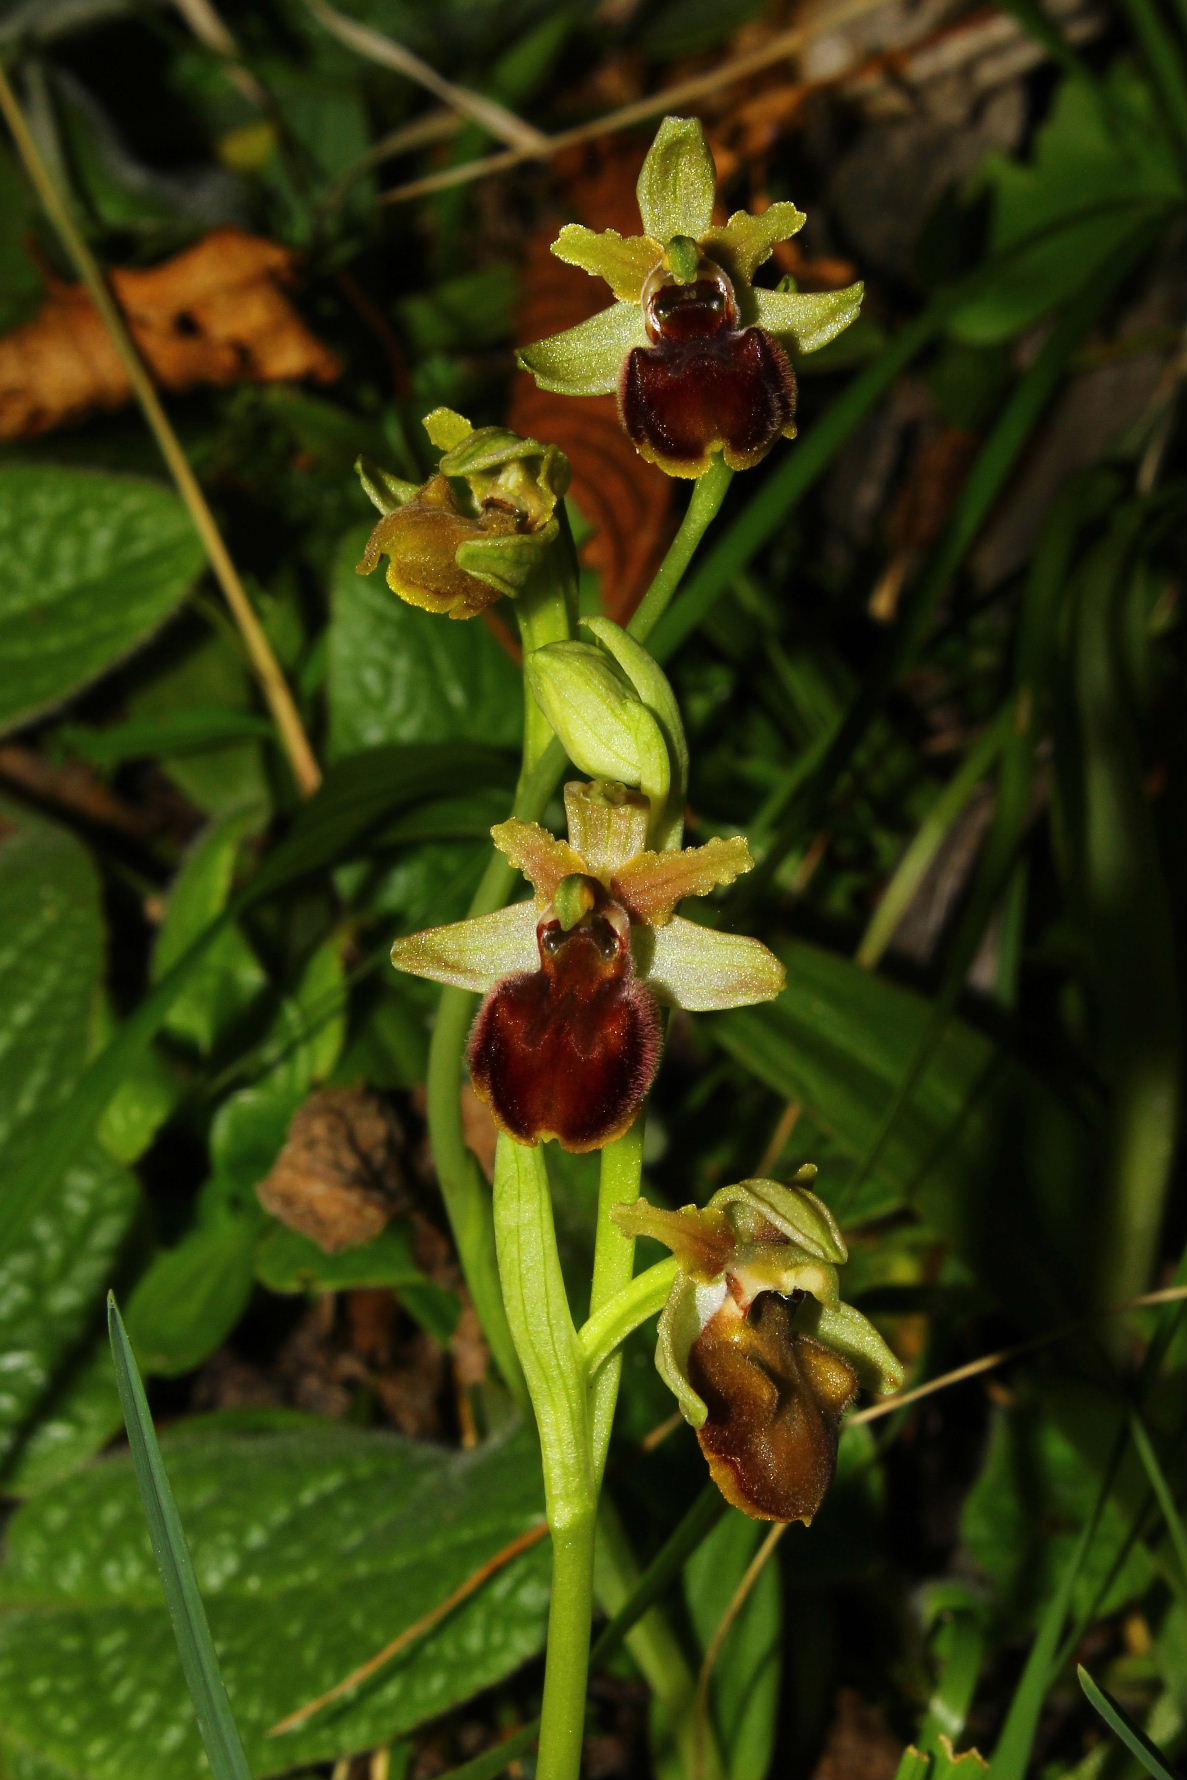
[0,228,342,440]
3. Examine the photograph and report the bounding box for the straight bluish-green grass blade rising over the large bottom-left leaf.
[107,1294,251,1780]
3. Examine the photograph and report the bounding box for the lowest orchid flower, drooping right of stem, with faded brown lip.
[614,1168,902,1524]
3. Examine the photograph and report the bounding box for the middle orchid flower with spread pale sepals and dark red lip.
[392,781,785,1150]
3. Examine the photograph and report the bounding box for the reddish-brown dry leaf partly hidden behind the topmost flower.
[509,137,673,625]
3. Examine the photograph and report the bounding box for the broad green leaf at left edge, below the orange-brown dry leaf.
[0,463,203,730]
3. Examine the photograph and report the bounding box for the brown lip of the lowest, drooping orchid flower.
[689,1292,858,1524]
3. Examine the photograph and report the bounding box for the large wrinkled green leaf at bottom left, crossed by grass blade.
[0,1422,548,1780]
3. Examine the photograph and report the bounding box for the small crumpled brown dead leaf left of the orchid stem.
[256,1088,408,1255]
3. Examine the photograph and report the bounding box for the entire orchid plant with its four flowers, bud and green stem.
[359,117,902,1780]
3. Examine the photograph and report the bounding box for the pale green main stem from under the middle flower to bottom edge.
[495,1136,598,1780]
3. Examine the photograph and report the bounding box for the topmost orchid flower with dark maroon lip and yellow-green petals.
[520,117,863,477]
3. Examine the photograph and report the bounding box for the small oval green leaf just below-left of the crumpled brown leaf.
[126,1218,256,1378]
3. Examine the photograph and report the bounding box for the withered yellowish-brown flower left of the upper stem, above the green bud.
[358,408,569,618]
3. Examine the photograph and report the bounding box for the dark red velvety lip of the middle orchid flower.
[470,911,660,1152]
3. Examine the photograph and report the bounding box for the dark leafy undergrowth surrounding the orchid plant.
[0,0,1187,1780]
